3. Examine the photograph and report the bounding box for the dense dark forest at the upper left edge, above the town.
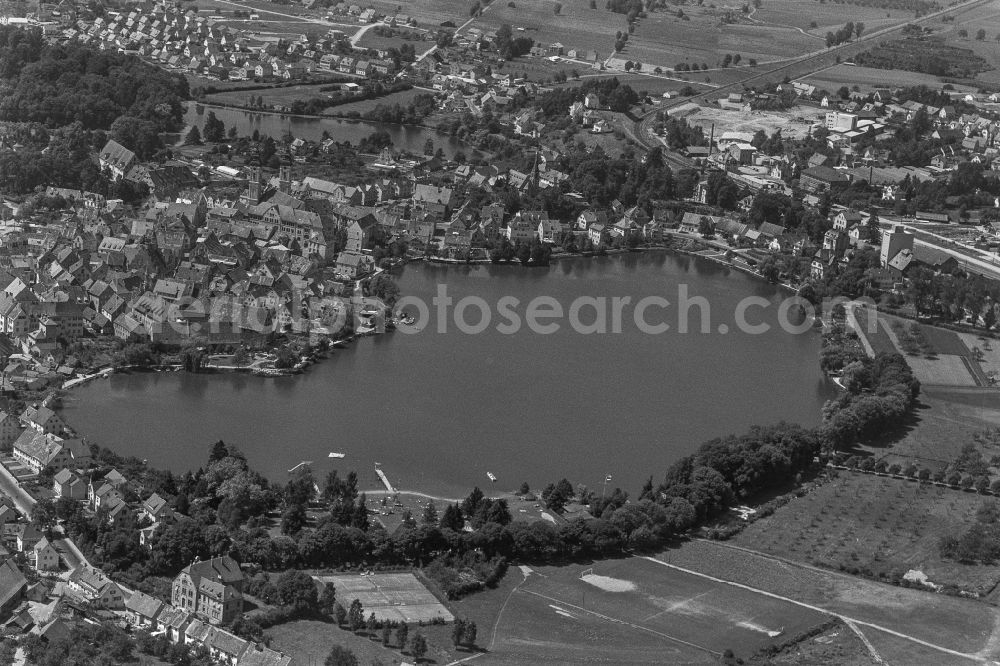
[0,26,189,131]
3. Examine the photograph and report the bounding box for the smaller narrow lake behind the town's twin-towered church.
[184,102,471,158]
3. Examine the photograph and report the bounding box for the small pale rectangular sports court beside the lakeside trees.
[313,573,455,623]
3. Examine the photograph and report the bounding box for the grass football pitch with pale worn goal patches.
[492,558,826,664]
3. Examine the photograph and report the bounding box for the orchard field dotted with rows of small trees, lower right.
[732,472,1000,593]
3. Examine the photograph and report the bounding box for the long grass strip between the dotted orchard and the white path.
[656,540,998,664]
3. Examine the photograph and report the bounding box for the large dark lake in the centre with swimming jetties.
[64,253,836,496]
